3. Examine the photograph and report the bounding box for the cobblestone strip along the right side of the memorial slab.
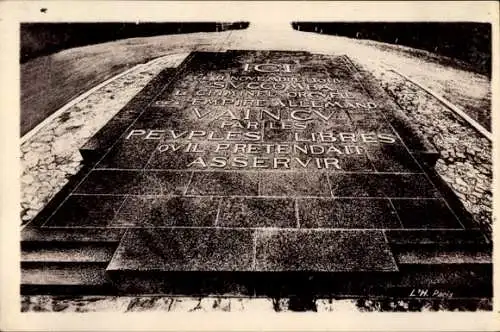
[374,71,493,230]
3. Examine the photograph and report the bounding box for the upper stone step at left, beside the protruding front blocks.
[21,243,116,264]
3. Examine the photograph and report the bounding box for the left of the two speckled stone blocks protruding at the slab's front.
[107,228,253,271]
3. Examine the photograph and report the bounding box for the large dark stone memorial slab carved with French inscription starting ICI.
[23,51,489,296]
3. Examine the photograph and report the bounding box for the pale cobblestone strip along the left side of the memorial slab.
[21,53,188,223]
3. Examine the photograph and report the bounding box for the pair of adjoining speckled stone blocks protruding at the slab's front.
[107,227,397,275]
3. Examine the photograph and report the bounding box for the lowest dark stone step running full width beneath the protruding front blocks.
[21,264,492,298]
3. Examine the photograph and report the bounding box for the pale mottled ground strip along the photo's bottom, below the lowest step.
[21,296,492,313]
